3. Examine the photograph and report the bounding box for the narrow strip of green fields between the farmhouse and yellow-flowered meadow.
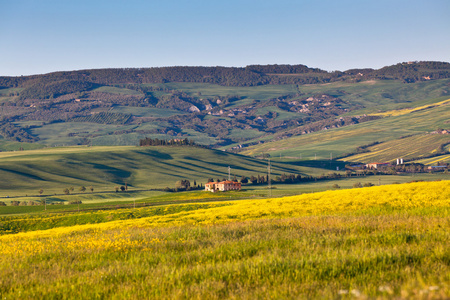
[0,172,450,216]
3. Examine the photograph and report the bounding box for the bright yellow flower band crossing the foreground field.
[0,181,450,248]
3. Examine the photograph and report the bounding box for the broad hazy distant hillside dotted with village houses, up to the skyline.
[0,62,450,164]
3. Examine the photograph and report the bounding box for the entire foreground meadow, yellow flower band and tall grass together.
[0,181,450,299]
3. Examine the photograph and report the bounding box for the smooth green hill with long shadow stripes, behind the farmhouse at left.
[0,146,320,196]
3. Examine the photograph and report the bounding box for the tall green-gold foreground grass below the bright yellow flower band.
[0,215,450,299]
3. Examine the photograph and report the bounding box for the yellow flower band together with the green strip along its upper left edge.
[0,181,450,237]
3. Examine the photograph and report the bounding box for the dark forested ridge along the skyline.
[0,62,450,89]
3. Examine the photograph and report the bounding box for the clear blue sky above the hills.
[0,0,450,76]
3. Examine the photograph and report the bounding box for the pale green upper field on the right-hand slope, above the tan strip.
[241,99,450,160]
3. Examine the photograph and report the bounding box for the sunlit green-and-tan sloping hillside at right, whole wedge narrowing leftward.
[241,94,450,163]
